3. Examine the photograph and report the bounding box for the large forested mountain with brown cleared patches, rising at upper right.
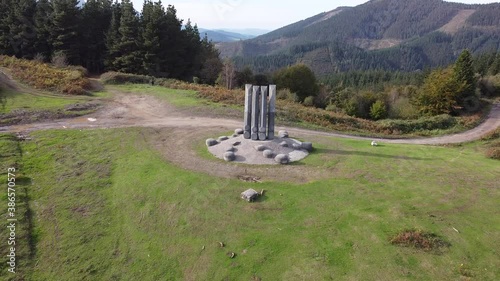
[221,0,500,75]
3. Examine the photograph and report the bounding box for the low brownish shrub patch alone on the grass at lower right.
[391,229,450,251]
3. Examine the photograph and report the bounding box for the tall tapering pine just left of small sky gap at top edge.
[113,0,144,74]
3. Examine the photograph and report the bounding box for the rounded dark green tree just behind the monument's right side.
[273,64,319,101]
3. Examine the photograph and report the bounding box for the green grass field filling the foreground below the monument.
[0,129,500,280]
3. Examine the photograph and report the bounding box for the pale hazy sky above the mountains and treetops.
[132,0,497,30]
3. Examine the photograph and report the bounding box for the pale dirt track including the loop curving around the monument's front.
[0,86,500,182]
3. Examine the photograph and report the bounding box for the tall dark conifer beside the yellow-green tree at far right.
[453,50,476,106]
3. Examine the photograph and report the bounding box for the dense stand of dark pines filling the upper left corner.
[0,0,222,84]
